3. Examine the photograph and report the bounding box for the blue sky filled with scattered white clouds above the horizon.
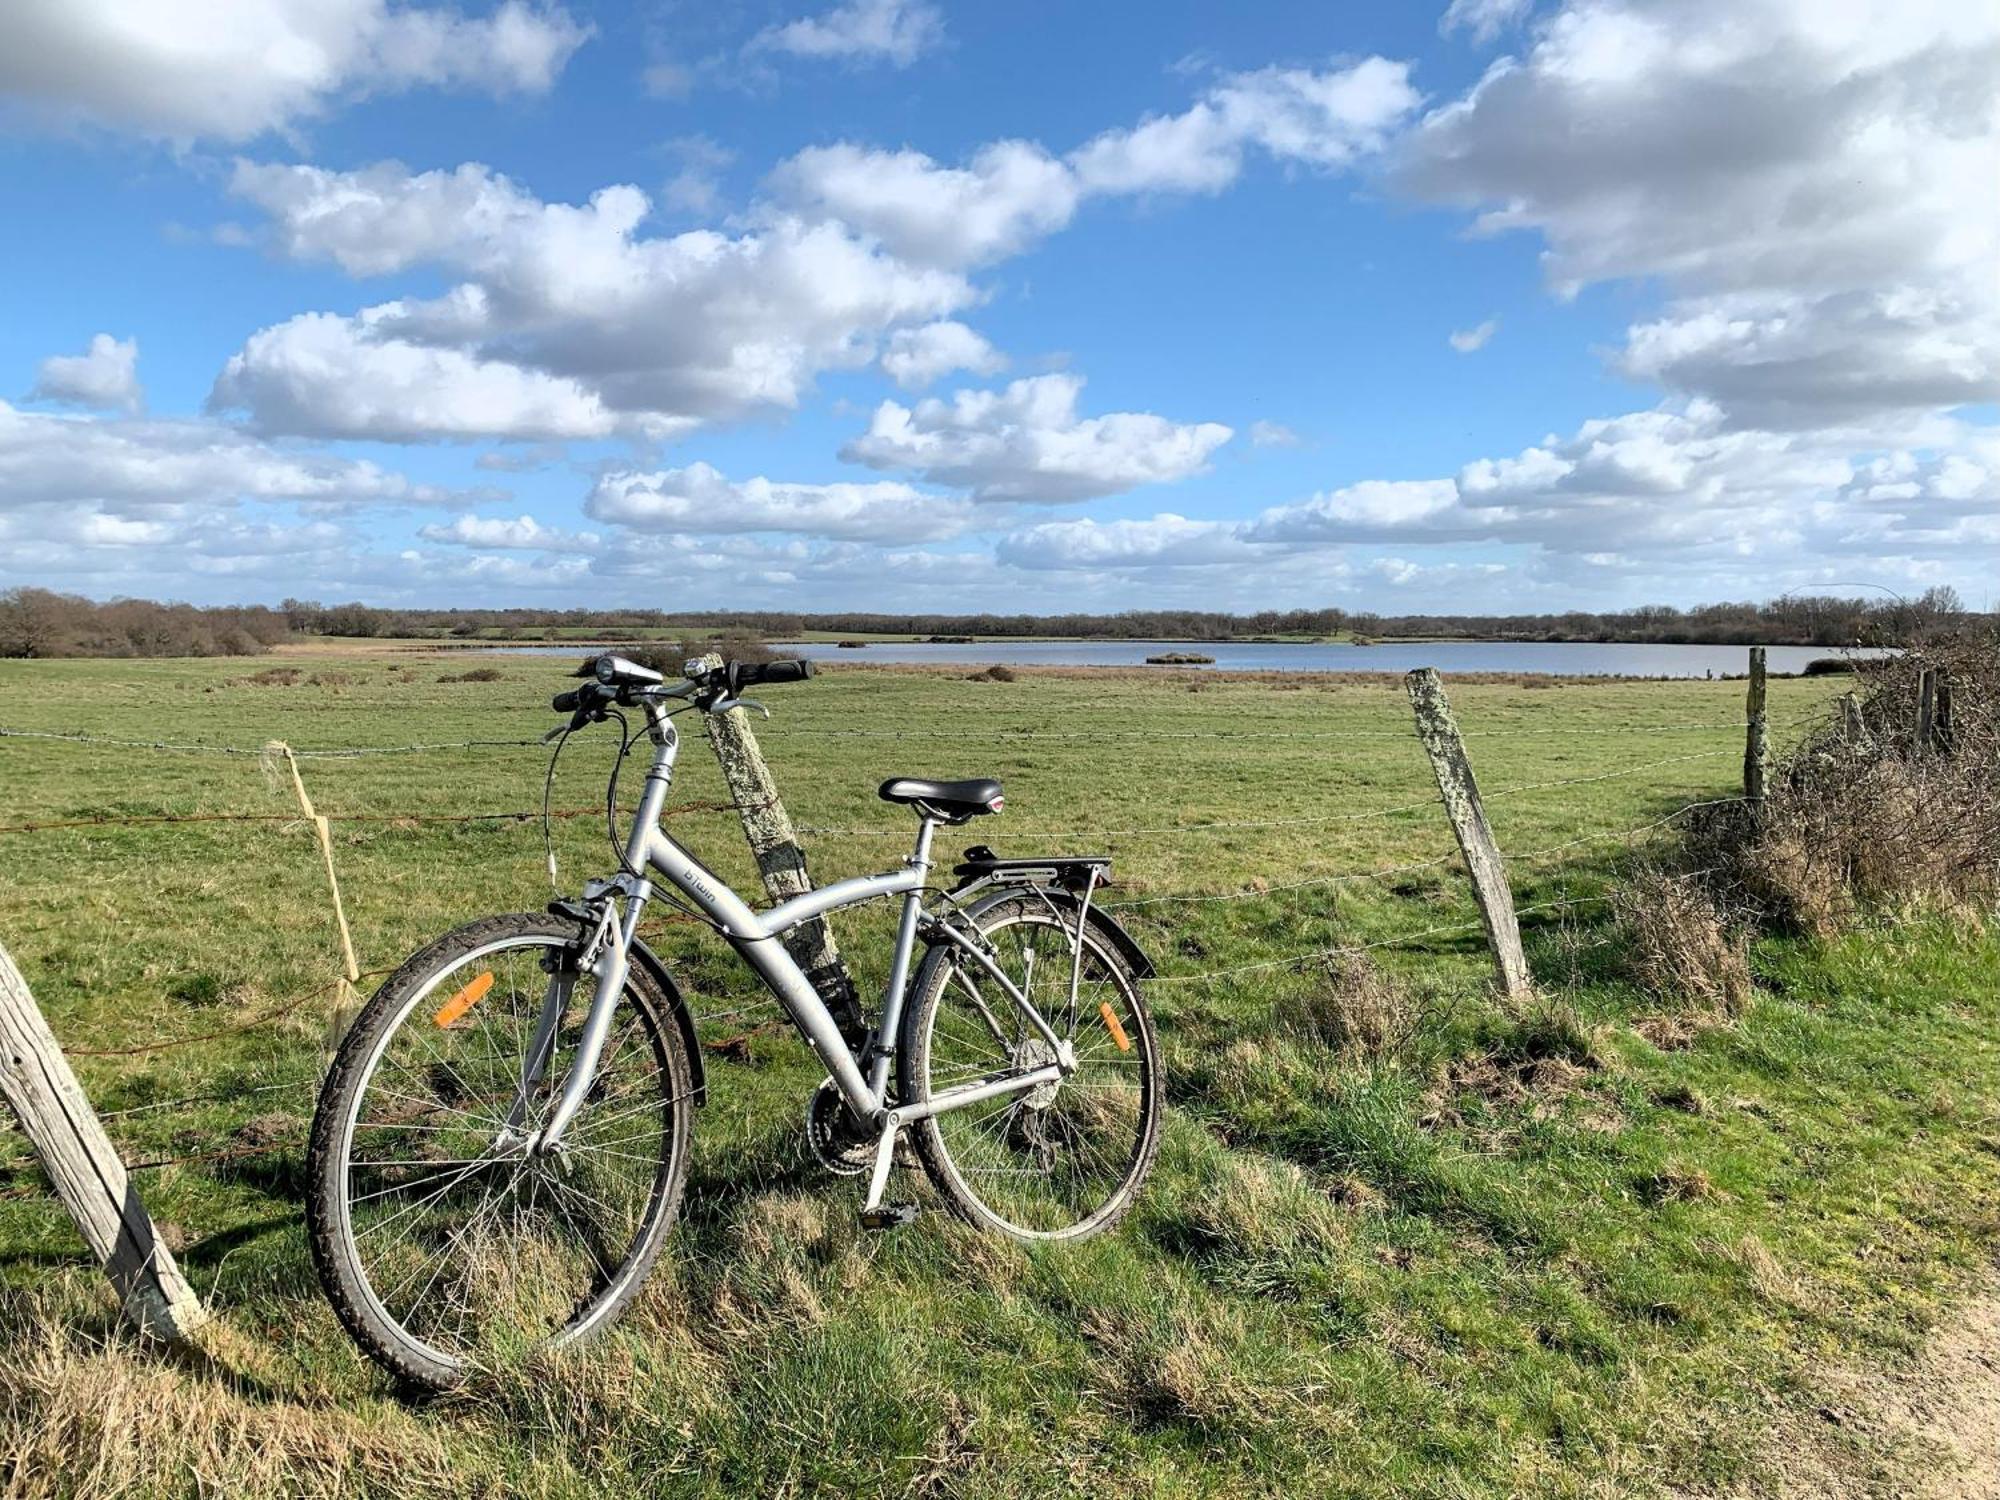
[0,0,2000,612]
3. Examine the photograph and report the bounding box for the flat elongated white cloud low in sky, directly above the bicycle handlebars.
[584,464,974,544]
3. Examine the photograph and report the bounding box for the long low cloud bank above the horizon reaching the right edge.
[998,402,2000,590]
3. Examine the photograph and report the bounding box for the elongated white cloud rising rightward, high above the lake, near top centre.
[770,58,1418,268]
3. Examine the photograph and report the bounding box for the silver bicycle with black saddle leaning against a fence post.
[306,656,1164,1390]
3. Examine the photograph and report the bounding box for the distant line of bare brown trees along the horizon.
[0,588,1990,656]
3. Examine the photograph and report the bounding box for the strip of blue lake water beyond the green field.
[498,640,1872,678]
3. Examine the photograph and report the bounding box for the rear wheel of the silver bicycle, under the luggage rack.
[902,898,1164,1240]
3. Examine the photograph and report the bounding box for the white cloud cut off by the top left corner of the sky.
[0,0,588,142]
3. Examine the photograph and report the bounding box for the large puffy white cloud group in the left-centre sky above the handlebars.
[216,164,974,440]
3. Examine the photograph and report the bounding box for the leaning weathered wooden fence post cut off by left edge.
[0,948,208,1344]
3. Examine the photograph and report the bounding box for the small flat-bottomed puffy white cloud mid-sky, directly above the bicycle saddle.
[840,374,1232,502]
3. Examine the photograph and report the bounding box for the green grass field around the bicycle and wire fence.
[0,650,2000,1496]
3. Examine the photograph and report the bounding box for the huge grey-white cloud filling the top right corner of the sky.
[1394,0,2000,430]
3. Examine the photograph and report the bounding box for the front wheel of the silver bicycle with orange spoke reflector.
[306,914,694,1390]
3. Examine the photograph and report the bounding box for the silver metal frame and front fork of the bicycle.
[524,702,1080,1184]
